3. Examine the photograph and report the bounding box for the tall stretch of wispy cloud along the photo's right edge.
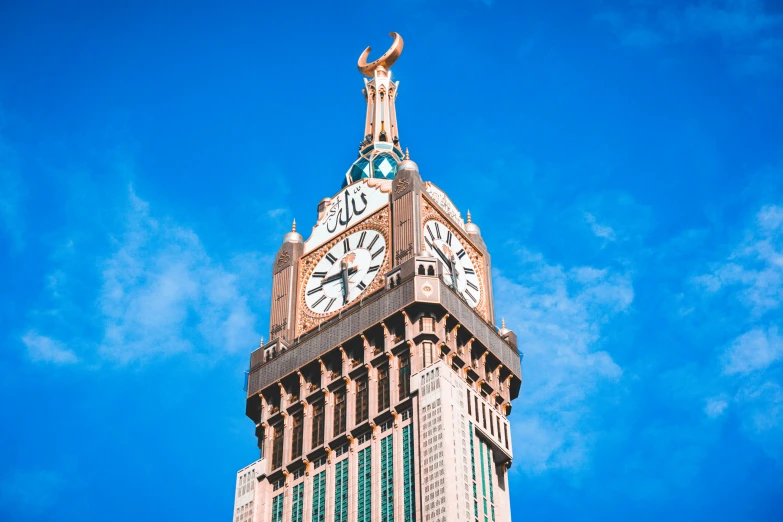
[693,205,783,458]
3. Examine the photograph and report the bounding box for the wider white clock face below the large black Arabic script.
[304,230,387,314]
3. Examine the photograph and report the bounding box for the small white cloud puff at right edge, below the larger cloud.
[723,327,783,375]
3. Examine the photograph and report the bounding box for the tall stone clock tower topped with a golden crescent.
[239,33,522,522]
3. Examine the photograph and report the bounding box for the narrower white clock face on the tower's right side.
[424,219,481,308]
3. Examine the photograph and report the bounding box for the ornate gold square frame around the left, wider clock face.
[296,205,392,336]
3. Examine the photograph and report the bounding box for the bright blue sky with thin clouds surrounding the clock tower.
[0,0,783,522]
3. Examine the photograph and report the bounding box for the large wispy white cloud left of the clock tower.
[99,186,259,363]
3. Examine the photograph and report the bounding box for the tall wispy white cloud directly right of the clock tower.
[494,246,634,472]
